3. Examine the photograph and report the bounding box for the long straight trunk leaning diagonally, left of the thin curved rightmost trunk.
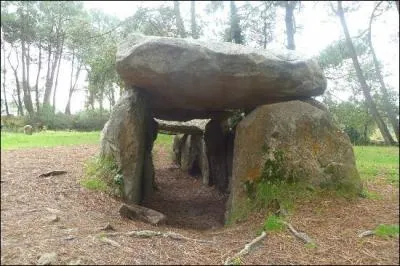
[338,1,394,145]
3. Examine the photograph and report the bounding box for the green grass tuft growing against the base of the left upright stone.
[81,156,123,197]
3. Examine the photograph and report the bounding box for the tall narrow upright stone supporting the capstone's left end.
[100,88,151,203]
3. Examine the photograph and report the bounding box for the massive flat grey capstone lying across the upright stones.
[116,35,326,120]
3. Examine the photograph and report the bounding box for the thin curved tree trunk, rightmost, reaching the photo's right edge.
[368,5,399,141]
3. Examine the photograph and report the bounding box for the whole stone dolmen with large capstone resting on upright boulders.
[101,34,362,222]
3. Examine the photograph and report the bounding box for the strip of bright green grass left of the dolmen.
[1,131,100,150]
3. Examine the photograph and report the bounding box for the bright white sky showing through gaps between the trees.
[1,1,399,113]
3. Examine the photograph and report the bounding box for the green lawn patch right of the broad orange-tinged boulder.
[354,146,399,185]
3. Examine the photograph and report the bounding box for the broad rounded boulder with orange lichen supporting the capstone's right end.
[228,101,362,219]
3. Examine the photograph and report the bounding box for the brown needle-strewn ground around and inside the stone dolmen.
[1,145,399,265]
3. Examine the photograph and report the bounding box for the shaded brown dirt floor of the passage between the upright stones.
[143,149,227,230]
